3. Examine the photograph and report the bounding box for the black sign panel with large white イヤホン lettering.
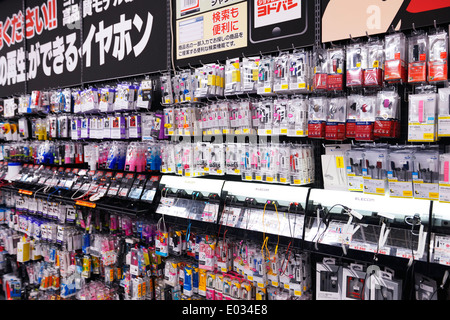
[81,0,168,82]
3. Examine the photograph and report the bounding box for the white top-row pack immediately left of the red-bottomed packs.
[289,50,311,93]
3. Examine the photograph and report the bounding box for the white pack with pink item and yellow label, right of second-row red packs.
[408,90,437,142]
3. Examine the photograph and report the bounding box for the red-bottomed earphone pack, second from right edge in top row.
[408,30,428,83]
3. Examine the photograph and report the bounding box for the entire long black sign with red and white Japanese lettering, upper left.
[0,0,168,97]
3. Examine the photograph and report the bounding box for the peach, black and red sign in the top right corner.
[322,0,450,42]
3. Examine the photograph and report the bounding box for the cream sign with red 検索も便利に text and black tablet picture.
[172,0,315,67]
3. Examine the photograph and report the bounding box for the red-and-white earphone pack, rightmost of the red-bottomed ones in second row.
[373,88,400,138]
